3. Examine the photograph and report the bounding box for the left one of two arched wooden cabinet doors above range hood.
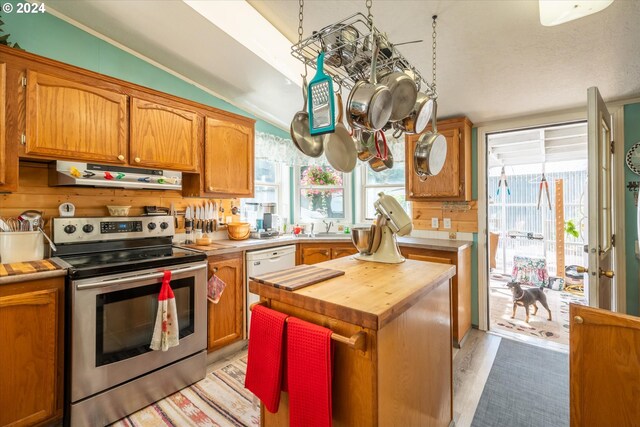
[25,71,128,163]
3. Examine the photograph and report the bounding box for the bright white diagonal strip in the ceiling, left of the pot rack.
[183,0,304,85]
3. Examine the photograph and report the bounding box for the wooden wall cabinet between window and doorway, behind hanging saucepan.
[405,117,473,201]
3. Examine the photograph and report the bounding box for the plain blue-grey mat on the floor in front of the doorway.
[471,338,569,427]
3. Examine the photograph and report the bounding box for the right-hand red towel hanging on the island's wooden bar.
[287,317,333,427]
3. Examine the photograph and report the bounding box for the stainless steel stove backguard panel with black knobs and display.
[53,215,175,244]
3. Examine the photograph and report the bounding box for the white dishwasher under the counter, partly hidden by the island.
[245,245,296,336]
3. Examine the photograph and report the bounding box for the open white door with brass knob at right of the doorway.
[587,87,616,310]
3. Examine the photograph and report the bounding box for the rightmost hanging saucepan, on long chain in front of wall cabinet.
[413,100,447,181]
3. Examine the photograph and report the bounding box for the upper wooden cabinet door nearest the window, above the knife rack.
[204,117,254,197]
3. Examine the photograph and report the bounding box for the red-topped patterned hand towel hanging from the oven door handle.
[149,271,180,351]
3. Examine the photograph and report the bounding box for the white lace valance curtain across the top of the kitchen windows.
[255,132,405,166]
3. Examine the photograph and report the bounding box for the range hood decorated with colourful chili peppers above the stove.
[49,161,182,190]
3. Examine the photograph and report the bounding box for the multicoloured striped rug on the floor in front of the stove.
[112,353,260,427]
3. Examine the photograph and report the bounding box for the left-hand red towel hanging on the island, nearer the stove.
[244,305,288,414]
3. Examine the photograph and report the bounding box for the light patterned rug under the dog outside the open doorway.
[489,278,586,345]
